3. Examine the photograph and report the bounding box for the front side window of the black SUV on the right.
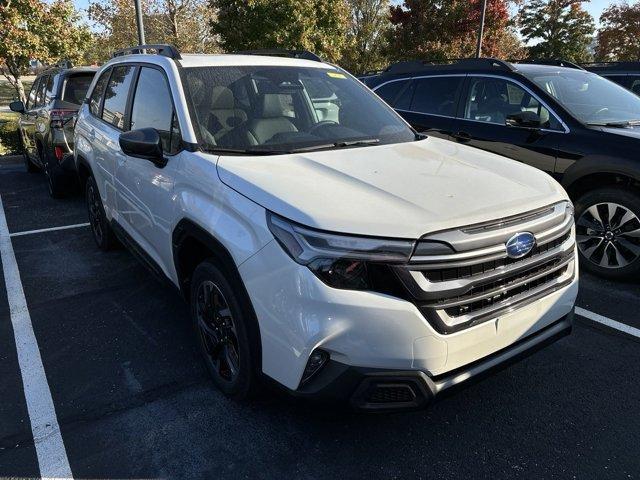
[464,77,560,129]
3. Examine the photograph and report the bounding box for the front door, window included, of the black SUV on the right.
[453,75,568,174]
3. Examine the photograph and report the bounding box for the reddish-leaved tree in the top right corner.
[596,2,640,61]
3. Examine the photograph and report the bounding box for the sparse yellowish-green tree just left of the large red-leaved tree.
[340,0,391,73]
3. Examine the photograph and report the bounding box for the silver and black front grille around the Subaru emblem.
[398,202,575,333]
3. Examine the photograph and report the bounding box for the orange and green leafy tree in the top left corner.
[0,0,91,101]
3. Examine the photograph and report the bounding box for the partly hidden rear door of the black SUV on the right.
[394,74,465,139]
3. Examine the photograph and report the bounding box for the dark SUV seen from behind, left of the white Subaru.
[9,62,97,197]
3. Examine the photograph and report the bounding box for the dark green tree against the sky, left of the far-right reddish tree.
[518,0,595,62]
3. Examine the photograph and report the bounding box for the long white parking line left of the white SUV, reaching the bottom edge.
[0,197,73,478]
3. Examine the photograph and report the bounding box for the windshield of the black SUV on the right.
[524,70,640,125]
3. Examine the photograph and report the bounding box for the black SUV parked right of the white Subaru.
[363,59,640,278]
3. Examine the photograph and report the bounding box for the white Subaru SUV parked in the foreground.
[75,45,578,410]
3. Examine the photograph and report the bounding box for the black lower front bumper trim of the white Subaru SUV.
[291,311,573,411]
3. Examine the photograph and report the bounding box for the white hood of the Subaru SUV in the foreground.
[217,137,567,239]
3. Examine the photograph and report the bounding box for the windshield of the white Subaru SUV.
[182,66,416,154]
